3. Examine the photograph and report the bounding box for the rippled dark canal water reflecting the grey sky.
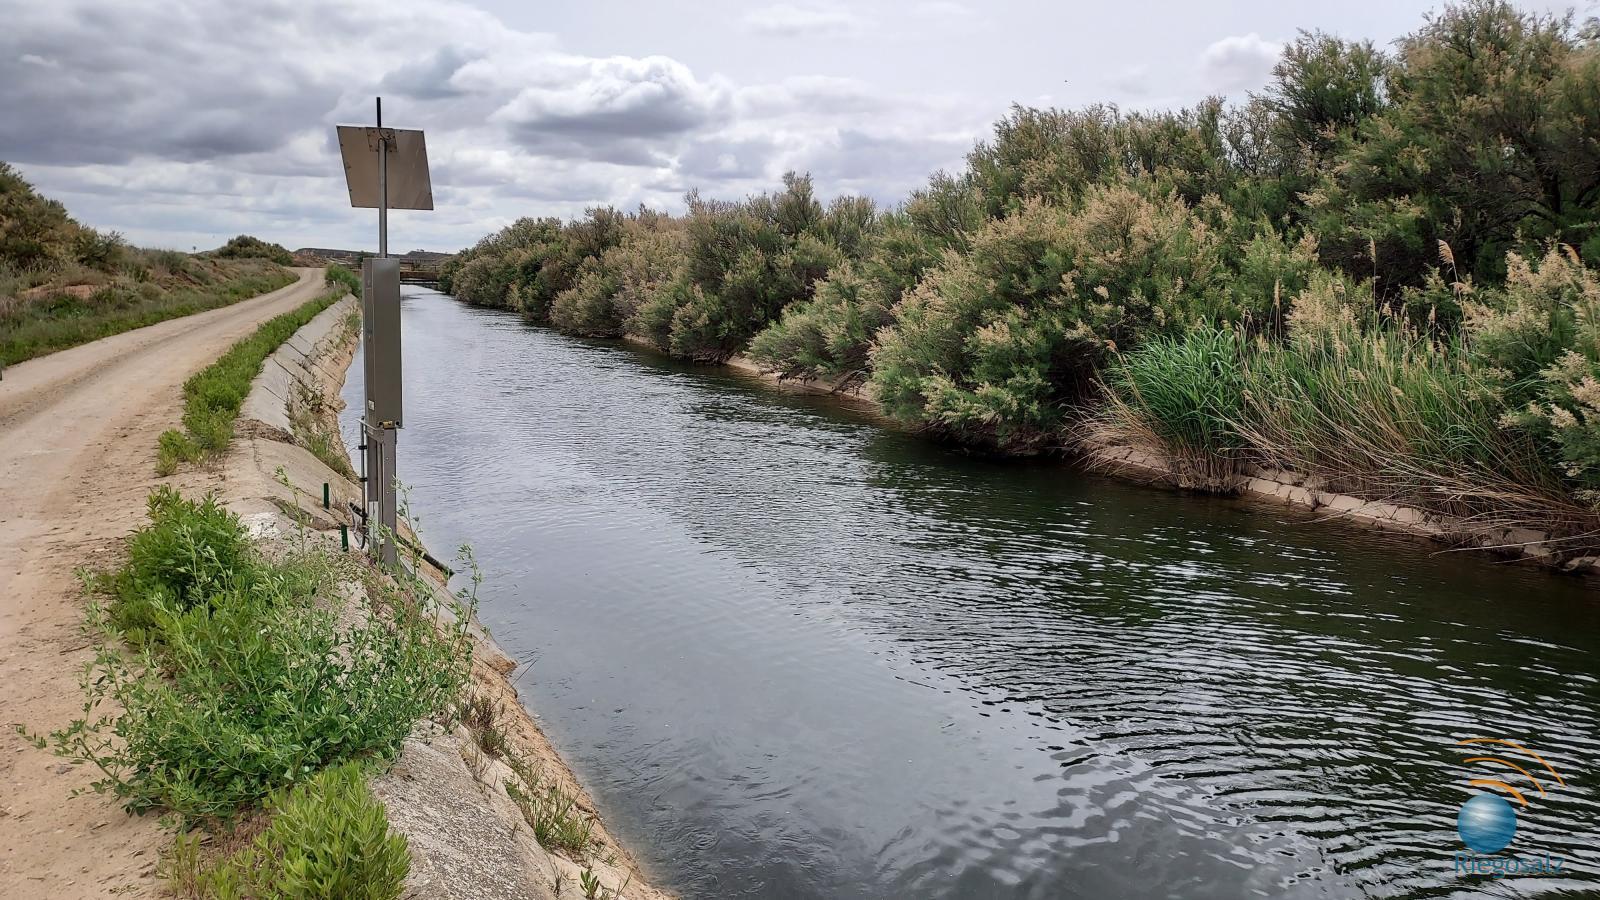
[346,288,1600,898]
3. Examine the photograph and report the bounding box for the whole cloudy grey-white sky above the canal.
[0,0,1594,250]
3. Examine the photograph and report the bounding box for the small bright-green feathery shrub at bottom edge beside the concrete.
[166,764,411,900]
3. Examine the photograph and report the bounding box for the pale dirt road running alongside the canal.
[0,269,323,898]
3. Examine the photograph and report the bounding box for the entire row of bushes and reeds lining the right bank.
[443,0,1600,549]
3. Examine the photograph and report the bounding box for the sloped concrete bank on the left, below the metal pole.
[219,296,669,900]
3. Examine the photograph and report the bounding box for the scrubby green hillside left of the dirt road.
[0,162,294,365]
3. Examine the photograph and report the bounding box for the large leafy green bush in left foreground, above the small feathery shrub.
[40,492,470,820]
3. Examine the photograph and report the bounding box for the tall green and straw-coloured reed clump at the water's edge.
[1080,293,1597,546]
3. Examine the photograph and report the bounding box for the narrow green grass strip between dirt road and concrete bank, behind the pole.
[155,264,360,476]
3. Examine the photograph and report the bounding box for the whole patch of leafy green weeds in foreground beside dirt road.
[25,487,472,900]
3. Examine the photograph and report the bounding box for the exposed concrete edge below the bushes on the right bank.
[726,356,1600,577]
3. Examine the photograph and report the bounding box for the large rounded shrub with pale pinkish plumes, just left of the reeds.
[872,186,1222,450]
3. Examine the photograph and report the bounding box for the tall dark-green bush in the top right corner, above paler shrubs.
[1307,0,1600,288]
